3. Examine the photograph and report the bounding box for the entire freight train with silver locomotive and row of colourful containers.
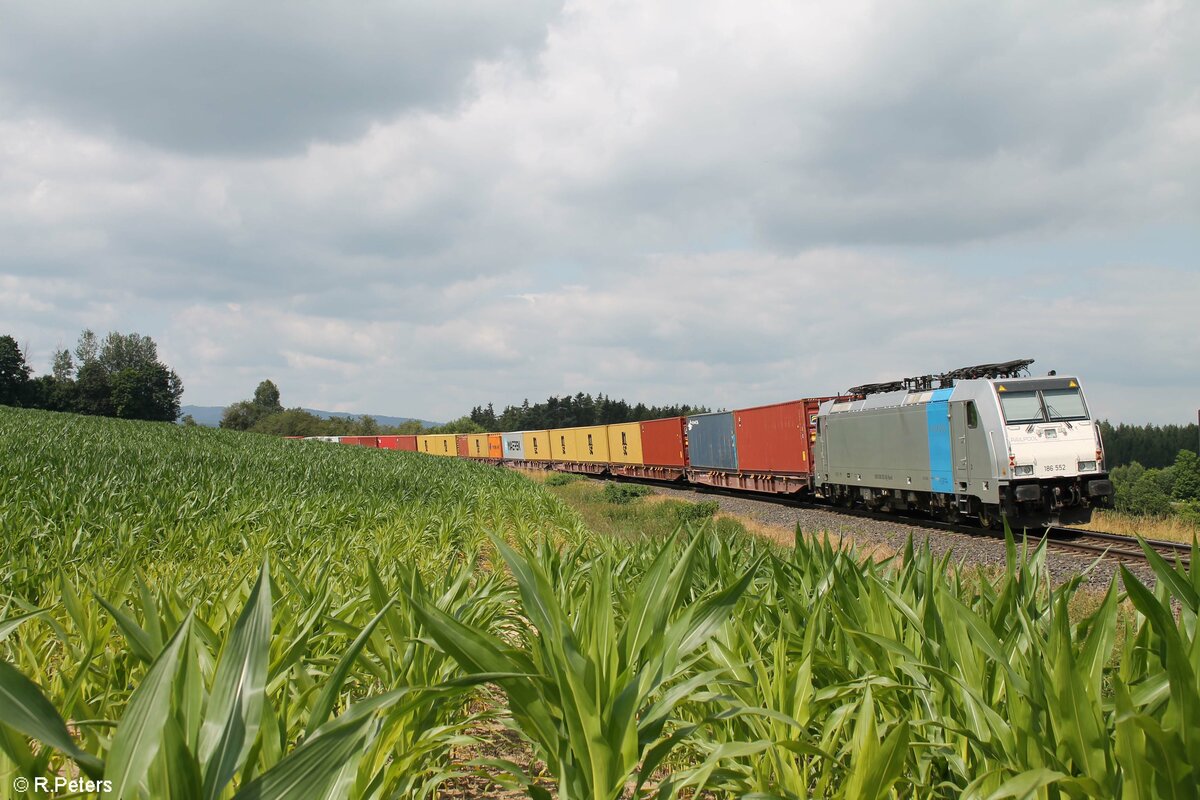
[309,359,1112,529]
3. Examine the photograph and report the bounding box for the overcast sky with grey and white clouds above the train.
[0,0,1200,422]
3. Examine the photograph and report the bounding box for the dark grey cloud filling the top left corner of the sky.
[0,0,558,156]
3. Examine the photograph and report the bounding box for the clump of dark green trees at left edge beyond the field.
[0,330,184,422]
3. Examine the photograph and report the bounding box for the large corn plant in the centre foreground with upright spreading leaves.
[414,539,752,800]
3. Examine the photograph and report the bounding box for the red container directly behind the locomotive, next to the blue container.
[733,397,826,475]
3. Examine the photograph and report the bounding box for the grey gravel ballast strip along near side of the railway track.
[654,487,1156,591]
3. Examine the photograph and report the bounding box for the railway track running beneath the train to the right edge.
[592,476,1192,567]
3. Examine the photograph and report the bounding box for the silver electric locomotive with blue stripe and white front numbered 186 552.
[814,359,1114,528]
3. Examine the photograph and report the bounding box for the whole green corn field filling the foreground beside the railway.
[0,408,1200,800]
